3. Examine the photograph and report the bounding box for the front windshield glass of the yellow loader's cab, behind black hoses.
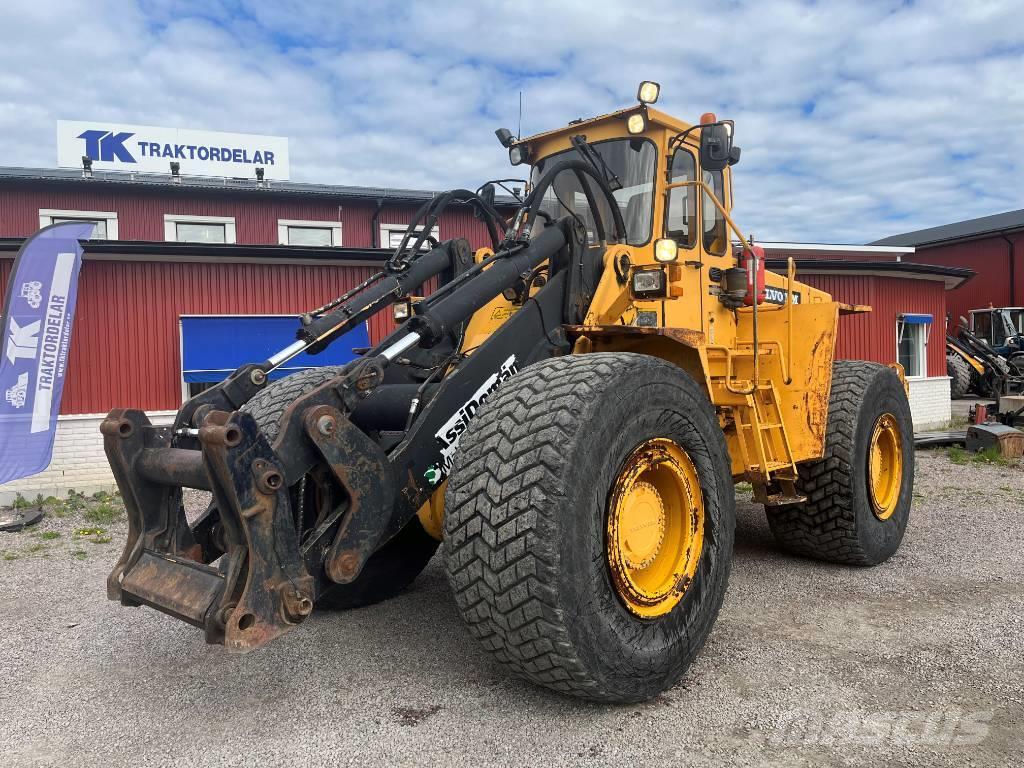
[530,138,657,246]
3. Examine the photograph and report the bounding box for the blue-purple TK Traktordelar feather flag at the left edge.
[0,221,94,482]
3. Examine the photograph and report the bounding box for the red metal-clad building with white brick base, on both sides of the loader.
[0,169,969,502]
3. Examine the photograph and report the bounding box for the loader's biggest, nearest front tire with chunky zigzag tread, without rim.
[444,353,735,702]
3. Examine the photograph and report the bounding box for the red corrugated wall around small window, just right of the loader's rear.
[798,268,946,376]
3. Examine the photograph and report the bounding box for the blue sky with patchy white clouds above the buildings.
[0,0,1024,243]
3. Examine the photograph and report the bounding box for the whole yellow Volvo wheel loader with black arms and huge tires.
[101,83,913,701]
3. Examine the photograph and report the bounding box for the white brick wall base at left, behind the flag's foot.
[0,411,176,505]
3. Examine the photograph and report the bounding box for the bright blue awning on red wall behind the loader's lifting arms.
[181,315,370,383]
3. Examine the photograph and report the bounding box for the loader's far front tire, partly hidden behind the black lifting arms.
[242,366,440,610]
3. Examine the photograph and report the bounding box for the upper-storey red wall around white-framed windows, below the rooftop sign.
[0,182,489,248]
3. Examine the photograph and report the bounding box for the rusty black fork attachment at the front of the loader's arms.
[100,409,314,651]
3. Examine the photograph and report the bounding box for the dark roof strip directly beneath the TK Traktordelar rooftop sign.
[0,166,516,206]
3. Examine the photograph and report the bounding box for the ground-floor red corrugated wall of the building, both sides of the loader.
[0,259,945,414]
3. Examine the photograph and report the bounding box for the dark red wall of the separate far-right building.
[907,234,1024,322]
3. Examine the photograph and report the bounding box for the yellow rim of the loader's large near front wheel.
[606,437,705,618]
